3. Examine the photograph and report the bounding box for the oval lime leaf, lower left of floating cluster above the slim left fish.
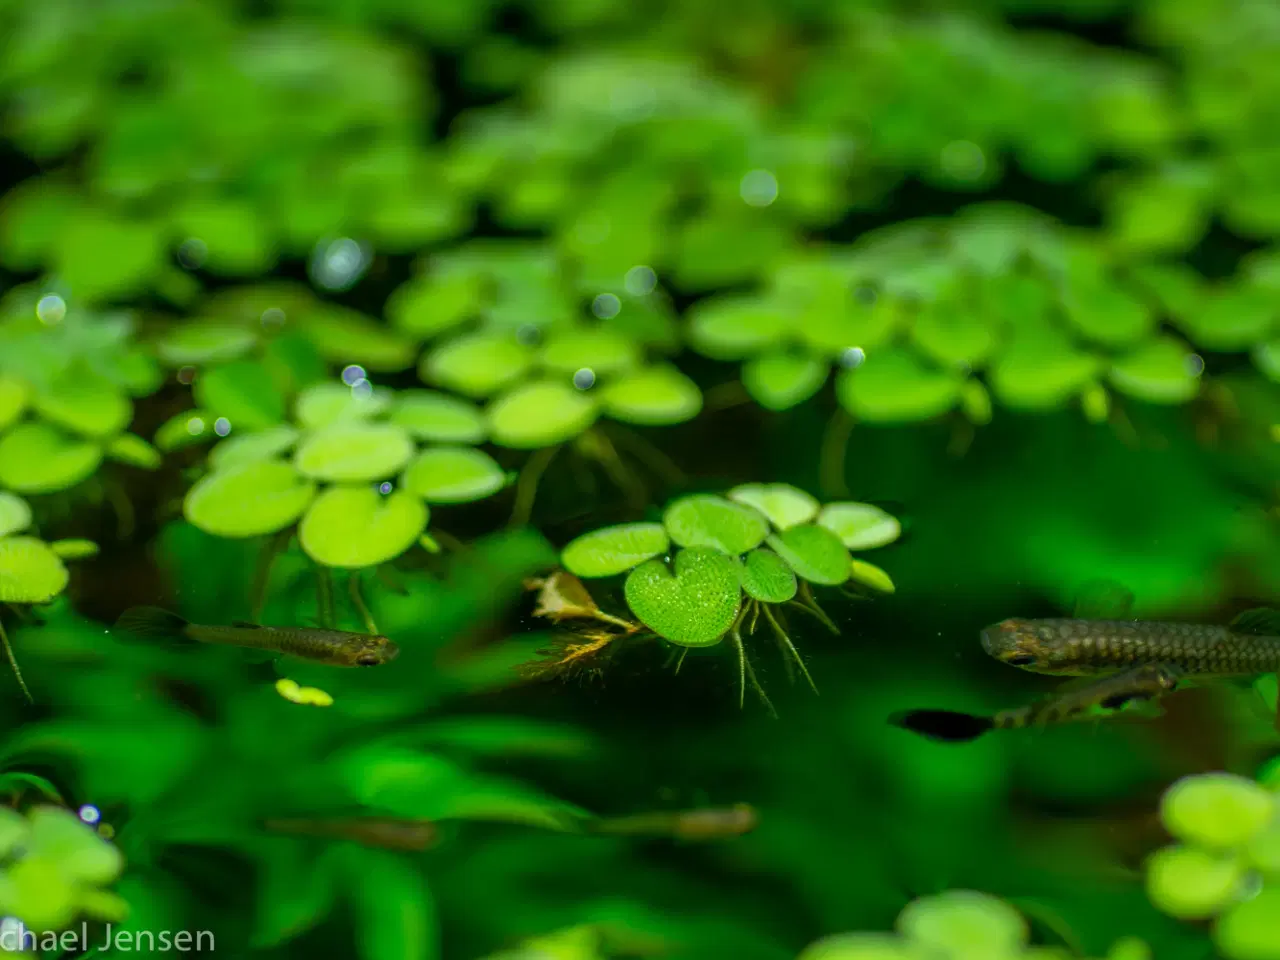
[182,460,316,538]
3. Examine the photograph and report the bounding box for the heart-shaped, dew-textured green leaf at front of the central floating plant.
[623,547,742,646]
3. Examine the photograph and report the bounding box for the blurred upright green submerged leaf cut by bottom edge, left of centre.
[343,846,440,960]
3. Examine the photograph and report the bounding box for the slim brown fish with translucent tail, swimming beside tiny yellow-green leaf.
[115,607,399,667]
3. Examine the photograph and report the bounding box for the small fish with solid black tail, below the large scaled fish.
[890,663,1181,742]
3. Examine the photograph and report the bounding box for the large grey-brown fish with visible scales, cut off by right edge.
[982,608,1280,677]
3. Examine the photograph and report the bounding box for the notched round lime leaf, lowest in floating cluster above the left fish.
[298,486,428,570]
